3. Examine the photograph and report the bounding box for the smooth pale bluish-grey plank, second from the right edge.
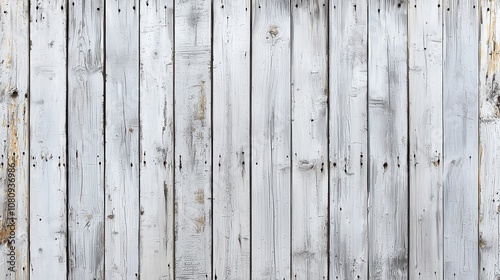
[443,0,479,279]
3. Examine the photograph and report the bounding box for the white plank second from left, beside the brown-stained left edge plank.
[30,0,67,279]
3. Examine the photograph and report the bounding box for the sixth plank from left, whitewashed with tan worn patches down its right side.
[174,0,212,279]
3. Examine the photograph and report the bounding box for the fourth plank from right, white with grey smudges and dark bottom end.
[368,0,408,279]
